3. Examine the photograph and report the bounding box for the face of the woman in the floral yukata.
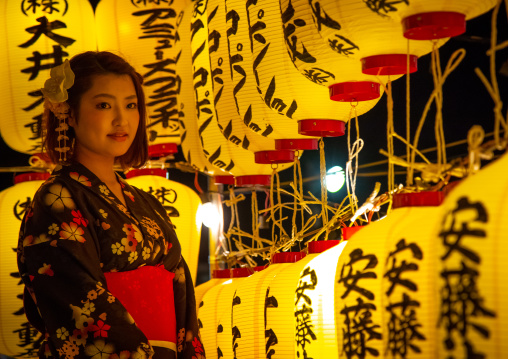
[69,74,139,163]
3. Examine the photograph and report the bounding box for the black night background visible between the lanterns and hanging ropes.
[0,0,508,282]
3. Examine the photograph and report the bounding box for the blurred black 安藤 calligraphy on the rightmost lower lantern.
[439,196,496,358]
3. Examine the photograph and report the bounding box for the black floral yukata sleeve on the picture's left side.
[18,183,153,359]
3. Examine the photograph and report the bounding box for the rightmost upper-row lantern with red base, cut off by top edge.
[376,0,496,40]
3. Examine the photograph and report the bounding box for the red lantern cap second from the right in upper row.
[361,54,418,76]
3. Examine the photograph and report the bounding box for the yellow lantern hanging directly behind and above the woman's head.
[95,0,190,157]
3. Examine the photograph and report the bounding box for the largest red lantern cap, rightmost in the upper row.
[402,11,466,40]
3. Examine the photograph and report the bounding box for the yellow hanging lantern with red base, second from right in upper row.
[314,0,445,75]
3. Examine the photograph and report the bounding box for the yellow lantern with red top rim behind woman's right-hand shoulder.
[126,168,201,282]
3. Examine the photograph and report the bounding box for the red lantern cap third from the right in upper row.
[328,81,380,102]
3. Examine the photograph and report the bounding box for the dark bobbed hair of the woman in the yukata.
[43,51,148,168]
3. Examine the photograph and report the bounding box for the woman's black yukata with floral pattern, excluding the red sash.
[17,164,204,359]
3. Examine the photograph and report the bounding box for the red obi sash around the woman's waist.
[104,266,176,351]
